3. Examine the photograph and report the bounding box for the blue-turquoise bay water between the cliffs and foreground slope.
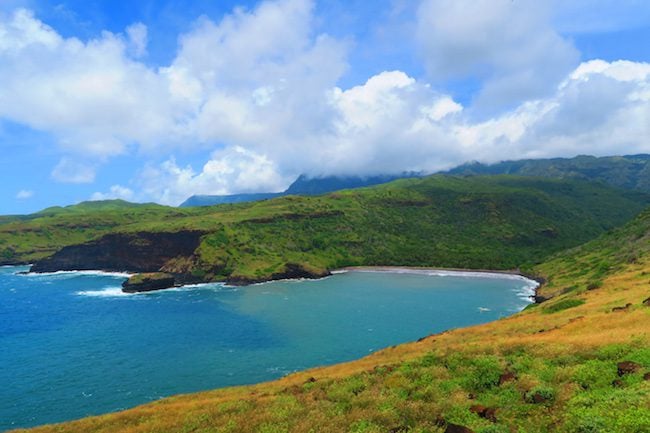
[0,267,531,431]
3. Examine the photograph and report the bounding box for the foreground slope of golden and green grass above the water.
[11,202,650,433]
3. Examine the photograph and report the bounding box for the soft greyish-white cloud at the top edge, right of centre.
[417,0,579,109]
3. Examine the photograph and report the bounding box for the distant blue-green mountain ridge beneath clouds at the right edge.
[449,155,650,192]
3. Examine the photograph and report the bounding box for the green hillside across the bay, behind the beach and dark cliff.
[0,176,650,282]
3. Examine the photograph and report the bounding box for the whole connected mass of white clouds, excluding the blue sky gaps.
[0,0,650,204]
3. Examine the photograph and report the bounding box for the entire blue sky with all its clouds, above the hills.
[0,0,650,214]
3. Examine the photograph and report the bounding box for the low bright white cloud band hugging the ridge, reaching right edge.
[76,61,650,205]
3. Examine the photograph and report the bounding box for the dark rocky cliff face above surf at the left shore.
[31,230,204,272]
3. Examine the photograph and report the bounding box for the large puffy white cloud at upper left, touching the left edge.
[0,9,174,157]
